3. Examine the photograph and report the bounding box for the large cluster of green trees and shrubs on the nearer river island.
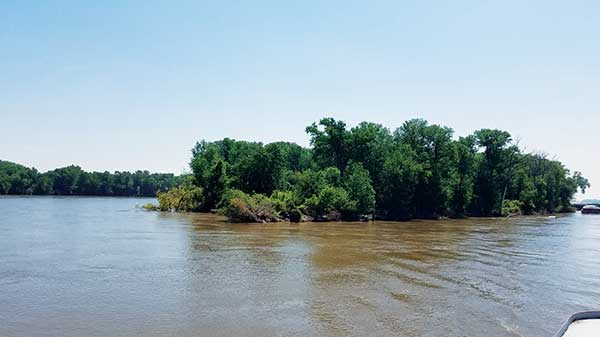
[152,118,590,222]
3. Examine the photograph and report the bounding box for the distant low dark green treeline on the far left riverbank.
[0,160,184,197]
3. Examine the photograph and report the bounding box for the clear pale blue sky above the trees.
[0,0,600,197]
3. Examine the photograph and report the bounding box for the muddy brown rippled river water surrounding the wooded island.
[0,197,600,337]
